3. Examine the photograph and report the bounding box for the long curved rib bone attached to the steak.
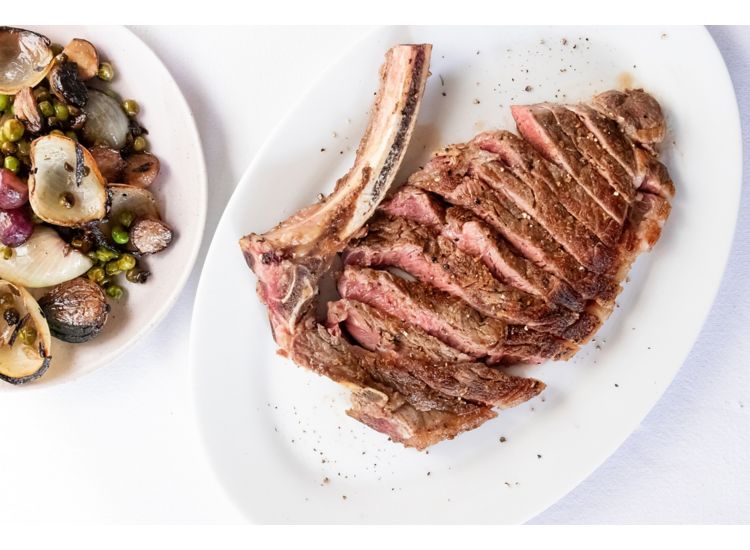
[240,44,432,348]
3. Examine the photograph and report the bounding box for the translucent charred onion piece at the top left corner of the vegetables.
[0,27,54,95]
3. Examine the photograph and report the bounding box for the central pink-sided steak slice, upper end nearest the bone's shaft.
[380,185,583,311]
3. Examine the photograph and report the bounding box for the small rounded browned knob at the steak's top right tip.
[592,90,667,146]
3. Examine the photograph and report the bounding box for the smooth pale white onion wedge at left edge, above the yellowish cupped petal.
[0,225,94,288]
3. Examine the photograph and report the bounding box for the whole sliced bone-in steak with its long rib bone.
[241,44,674,449]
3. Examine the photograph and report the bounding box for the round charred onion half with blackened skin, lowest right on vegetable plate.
[39,277,109,344]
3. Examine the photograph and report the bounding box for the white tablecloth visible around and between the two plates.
[0,27,750,523]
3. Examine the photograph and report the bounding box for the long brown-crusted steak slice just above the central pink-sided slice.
[409,160,616,299]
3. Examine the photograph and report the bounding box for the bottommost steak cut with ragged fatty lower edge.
[290,317,544,448]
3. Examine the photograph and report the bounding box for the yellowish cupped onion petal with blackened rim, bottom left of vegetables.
[0,280,52,384]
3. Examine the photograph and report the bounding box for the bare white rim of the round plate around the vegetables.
[0,26,206,391]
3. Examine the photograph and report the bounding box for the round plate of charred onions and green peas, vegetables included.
[0,27,206,390]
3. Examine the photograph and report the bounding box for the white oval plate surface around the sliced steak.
[191,27,741,523]
